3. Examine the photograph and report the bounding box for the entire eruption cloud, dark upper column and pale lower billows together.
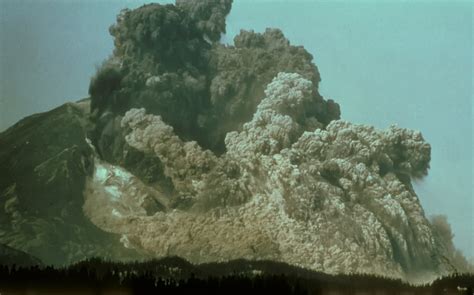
[80,0,465,278]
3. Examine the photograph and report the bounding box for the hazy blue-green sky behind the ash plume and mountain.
[0,0,474,256]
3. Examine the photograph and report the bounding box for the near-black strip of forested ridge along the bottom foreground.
[0,257,474,295]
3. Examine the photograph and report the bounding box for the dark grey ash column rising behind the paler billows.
[89,1,340,160]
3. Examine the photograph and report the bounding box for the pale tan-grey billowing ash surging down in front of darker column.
[82,73,470,278]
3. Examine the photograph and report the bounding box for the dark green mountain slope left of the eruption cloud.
[0,101,144,264]
